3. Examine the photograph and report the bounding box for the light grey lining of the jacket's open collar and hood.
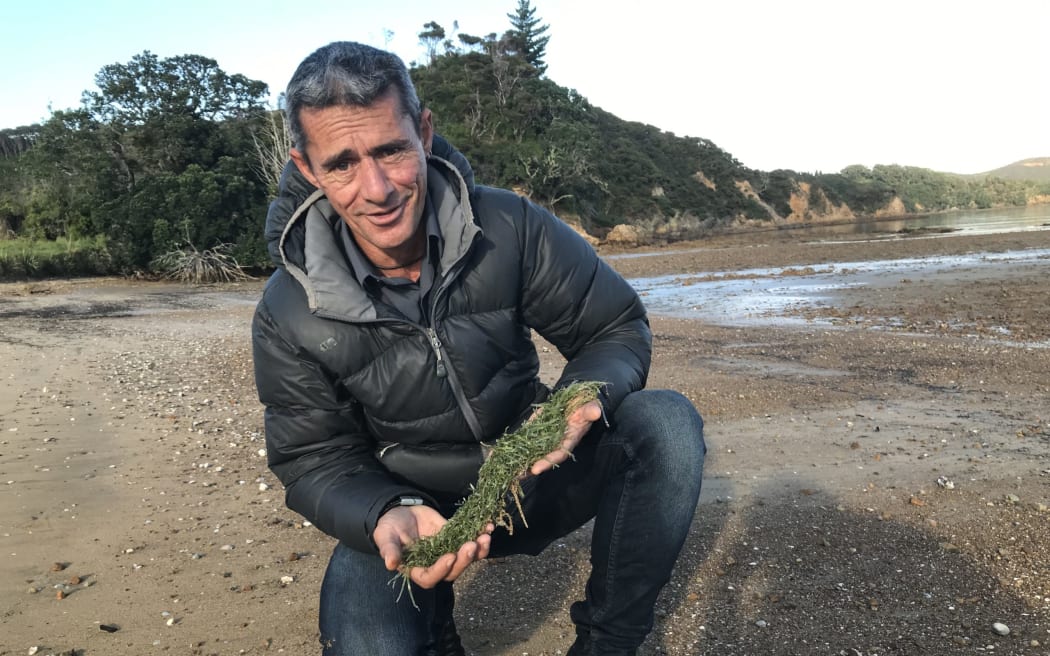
[278,155,481,321]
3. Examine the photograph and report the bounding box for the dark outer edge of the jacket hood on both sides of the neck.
[265,134,475,267]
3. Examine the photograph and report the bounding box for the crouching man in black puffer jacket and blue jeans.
[252,43,706,656]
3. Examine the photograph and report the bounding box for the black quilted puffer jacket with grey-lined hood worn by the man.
[252,139,651,551]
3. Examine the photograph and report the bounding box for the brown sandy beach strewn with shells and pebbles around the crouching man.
[0,230,1050,656]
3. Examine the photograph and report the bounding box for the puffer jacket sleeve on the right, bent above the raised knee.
[514,198,652,409]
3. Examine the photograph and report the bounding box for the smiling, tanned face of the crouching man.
[292,90,434,259]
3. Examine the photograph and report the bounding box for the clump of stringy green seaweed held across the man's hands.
[399,381,605,570]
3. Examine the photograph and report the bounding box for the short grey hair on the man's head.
[285,41,422,155]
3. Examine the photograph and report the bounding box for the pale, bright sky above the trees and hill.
[0,0,1050,173]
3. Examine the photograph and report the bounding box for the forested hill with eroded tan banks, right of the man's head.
[413,44,1050,238]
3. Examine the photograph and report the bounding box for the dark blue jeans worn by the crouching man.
[312,390,707,656]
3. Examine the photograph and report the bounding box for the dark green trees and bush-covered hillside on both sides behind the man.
[0,0,1050,278]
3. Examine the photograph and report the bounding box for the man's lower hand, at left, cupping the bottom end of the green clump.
[372,506,495,589]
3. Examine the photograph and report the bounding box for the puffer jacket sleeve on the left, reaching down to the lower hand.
[252,271,433,553]
